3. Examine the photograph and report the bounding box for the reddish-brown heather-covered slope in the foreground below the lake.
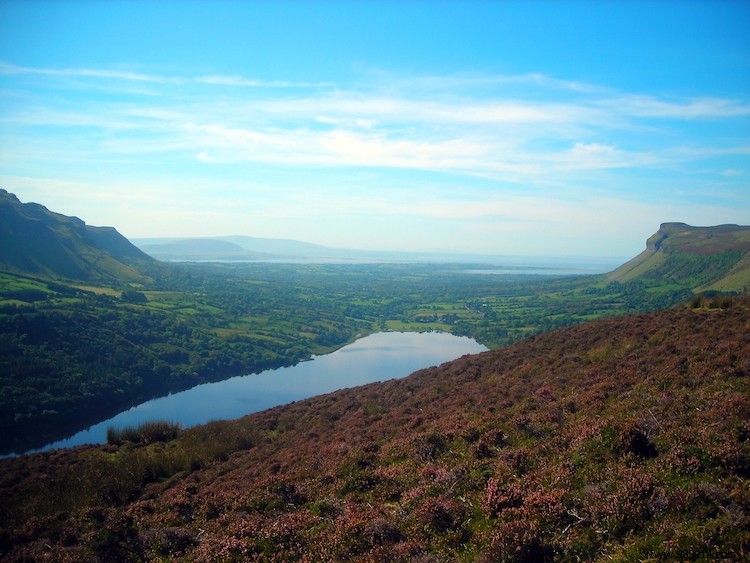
[0,300,750,561]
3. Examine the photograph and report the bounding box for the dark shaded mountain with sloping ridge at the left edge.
[0,189,155,282]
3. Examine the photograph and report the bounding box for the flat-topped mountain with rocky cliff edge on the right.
[607,223,750,292]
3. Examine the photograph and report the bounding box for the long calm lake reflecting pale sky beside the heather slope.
[34,332,487,451]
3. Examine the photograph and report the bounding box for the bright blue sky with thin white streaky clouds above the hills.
[0,0,750,257]
